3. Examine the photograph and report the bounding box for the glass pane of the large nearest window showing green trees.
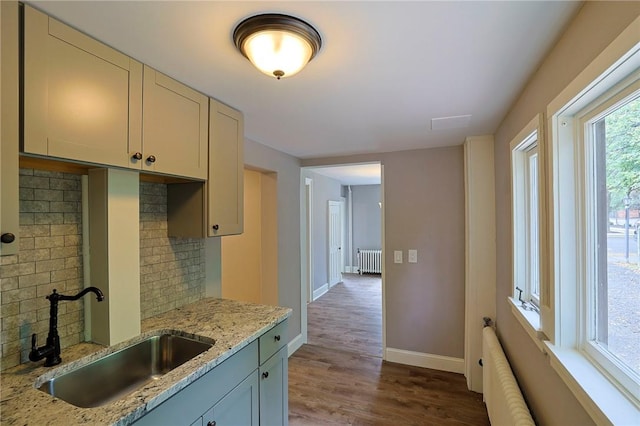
[592,94,640,375]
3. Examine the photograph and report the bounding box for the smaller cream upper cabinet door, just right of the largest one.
[140,65,209,180]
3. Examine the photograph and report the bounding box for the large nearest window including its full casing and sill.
[540,25,640,424]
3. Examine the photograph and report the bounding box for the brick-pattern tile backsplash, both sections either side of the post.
[0,169,205,370]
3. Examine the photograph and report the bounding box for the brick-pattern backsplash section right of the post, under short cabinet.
[140,182,205,319]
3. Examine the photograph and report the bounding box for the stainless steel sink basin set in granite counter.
[39,334,213,408]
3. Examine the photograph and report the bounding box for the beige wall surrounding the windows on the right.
[495,2,640,425]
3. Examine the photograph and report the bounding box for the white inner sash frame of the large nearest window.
[574,78,640,404]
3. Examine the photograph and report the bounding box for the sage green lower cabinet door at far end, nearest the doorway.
[260,346,289,426]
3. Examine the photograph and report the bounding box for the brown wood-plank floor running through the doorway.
[289,274,489,426]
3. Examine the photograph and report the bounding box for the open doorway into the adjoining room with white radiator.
[301,163,384,356]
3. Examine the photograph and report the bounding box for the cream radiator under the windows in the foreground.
[482,327,535,426]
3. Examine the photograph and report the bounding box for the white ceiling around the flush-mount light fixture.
[29,1,580,163]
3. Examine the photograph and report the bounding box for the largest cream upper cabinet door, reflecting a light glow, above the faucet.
[22,6,142,167]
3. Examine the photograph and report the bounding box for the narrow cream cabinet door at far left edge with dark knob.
[0,1,20,255]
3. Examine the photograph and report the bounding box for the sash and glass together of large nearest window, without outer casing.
[576,89,640,398]
